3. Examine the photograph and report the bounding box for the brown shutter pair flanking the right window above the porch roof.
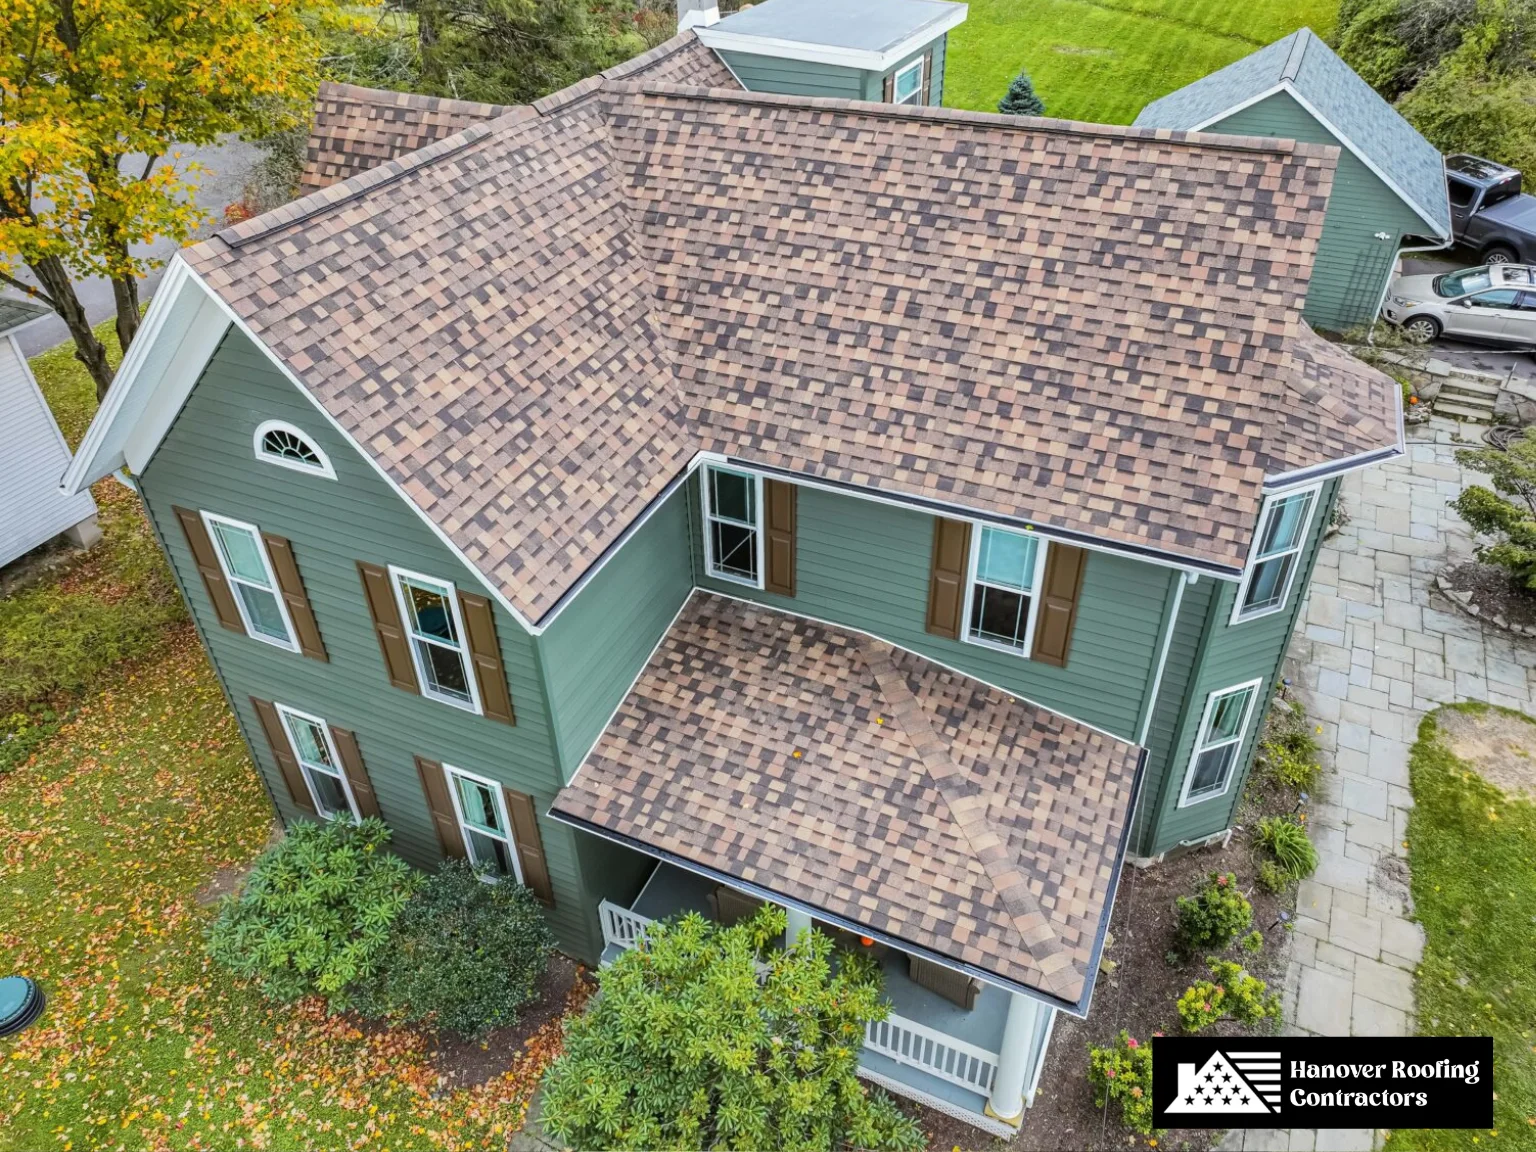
[928,516,1087,668]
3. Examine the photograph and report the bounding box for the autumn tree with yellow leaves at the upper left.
[0,0,335,396]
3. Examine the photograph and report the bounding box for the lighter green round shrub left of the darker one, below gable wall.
[207,817,419,1008]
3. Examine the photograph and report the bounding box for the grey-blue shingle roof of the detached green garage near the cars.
[1135,28,1450,240]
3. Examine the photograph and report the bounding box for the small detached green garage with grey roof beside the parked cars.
[1135,28,1452,332]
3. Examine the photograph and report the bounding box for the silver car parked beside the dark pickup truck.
[1381,264,1536,344]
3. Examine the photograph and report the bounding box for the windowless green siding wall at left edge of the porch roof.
[539,490,693,780]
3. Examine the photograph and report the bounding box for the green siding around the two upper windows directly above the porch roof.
[688,476,1172,740]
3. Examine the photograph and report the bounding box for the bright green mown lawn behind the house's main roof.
[945,0,1338,124]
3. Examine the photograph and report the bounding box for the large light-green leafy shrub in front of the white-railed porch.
[544,908,923,1152]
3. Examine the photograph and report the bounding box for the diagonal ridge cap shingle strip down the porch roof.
[854,633,1081,989]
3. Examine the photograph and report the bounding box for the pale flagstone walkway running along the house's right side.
[1221,418,1536,1152]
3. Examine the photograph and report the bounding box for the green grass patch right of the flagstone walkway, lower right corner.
[1389,705,1536,1152]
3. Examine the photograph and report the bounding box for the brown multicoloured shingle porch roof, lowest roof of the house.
[551,591,1140,1011]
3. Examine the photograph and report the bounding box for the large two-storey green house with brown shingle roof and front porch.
[63,22,1402,1135]
